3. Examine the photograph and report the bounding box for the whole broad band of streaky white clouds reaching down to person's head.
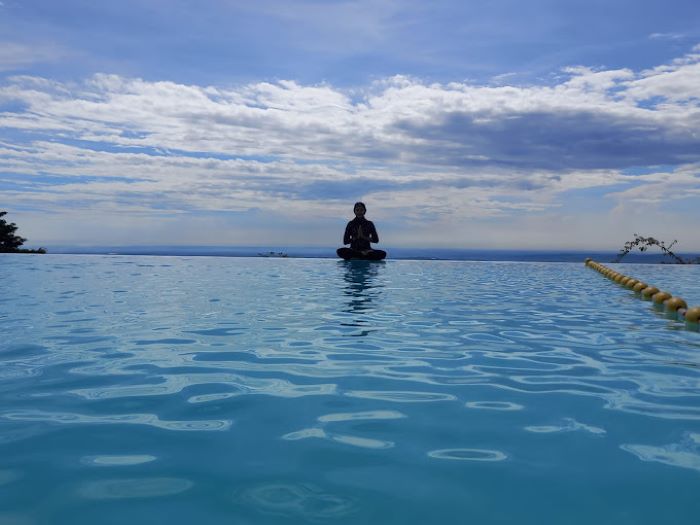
[0,45,700,246]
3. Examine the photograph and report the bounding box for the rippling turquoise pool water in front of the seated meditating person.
[0,255,700,525]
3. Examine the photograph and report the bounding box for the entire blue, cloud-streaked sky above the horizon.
[0,0,700,252]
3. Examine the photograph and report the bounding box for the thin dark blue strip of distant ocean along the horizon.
[41,246,700,264]
